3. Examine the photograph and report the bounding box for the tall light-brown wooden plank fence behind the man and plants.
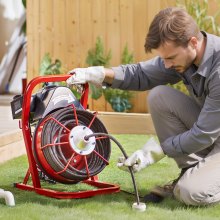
[27,0,175,112]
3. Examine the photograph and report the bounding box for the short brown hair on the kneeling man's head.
[144,7,202,53]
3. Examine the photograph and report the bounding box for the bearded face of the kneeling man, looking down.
[157,41,196,73]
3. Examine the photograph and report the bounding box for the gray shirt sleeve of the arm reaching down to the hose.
[161,71,220,157]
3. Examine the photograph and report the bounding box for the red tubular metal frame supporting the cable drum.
[15,75,120,199]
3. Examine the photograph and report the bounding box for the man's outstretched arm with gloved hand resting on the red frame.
[67,57,181,91]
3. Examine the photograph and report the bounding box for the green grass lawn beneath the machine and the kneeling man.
[0,135,220,220]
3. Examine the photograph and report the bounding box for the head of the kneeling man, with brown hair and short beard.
[145,8,203,72]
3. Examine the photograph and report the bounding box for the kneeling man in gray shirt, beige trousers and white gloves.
[67,8,220,206]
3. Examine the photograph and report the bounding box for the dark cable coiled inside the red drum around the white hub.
[33,107,111,183]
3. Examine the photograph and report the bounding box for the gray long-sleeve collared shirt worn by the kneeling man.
[112,33,220,157]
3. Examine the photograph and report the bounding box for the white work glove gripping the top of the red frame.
[66,66,105,87]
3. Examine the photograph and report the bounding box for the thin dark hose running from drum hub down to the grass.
[84,133,140,205]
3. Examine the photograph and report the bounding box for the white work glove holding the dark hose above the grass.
[117,138,165,172]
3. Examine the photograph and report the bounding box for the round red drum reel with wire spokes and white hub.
[32,106,111,183]
